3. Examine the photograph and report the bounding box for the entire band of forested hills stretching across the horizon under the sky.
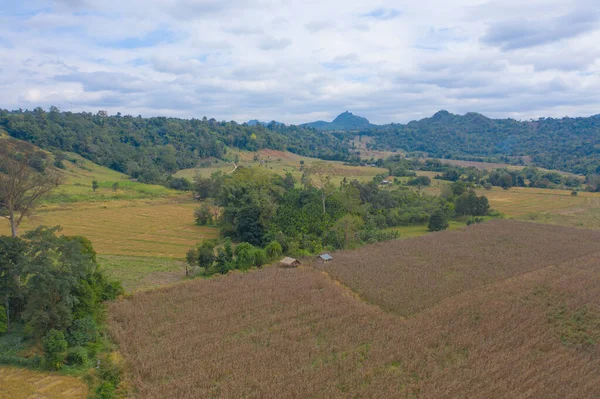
[0,107,600,182]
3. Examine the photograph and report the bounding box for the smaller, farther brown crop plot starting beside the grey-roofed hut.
[315,220,600,316]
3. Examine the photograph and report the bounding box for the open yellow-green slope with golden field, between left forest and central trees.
[0,139,218,290]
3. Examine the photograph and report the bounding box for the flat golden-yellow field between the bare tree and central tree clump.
[1,200,218,258]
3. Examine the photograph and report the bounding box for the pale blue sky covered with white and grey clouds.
[0,0,600,124]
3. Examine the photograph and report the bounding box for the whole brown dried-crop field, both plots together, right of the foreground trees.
[109,221,600,398]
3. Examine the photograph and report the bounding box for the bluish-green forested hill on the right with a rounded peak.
[370,111,600,174]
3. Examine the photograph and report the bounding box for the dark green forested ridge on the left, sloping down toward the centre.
[0,107,349,182]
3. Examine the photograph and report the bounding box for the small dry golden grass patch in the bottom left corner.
[0,367,88,399]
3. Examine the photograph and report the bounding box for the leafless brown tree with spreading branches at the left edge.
[0,140,62,237]
